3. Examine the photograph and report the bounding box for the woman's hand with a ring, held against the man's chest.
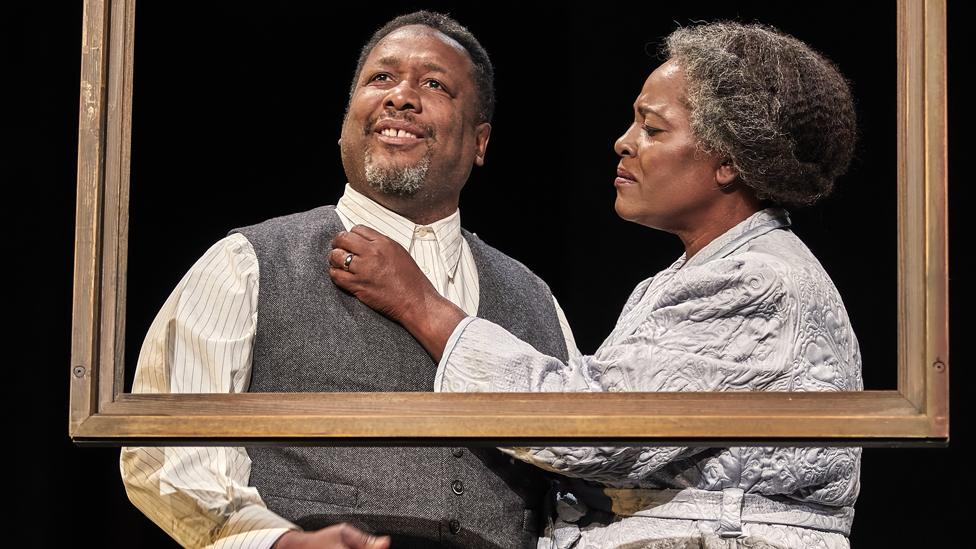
[329,225,466,362]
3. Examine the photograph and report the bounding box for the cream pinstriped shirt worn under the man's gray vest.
[120,185,578,548]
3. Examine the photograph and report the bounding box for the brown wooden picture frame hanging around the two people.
[69,0,949,446]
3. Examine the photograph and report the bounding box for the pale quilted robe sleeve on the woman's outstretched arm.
[435,260,795,486]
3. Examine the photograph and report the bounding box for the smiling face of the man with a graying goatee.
[341,25,491,198]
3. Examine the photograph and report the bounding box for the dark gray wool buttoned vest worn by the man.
[233,206,567,548]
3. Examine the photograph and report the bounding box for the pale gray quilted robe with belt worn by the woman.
[435,209,863,547]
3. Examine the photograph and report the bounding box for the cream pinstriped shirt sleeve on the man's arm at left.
[120,234,298,548]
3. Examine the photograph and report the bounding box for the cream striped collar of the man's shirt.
[336,183,462,278]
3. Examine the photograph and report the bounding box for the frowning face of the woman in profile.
[614,60,734,233]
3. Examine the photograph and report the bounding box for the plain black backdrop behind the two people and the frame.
[19,2,972,547]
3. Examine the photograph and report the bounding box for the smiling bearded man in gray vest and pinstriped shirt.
[122,12,575,547]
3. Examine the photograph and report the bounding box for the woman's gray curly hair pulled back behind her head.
[664,22,857,205]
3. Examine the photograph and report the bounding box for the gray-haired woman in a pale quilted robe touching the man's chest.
[329,23,862,547]
